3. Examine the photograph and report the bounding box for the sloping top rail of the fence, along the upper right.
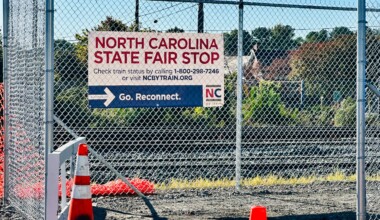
[148,0,380,12]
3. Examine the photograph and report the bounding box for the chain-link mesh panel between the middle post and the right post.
[242,1,356,215]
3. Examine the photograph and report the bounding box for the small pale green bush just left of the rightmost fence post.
[334,98,356,127]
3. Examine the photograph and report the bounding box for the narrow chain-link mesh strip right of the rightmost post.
[365,1,380,220]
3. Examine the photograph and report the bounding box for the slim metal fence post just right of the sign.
[236,0,244,190]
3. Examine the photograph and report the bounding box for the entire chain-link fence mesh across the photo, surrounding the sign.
[7,0,380,219]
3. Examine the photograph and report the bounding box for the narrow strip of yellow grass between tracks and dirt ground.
[155,171,380,190]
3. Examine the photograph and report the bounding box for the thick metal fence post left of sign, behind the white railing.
[45,0,56,219]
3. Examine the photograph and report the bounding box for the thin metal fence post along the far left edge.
[2,0,9,203]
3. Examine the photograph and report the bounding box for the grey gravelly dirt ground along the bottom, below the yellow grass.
[0,182,380,220]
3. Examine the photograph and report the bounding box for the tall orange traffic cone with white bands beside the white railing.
[68,144,94,220]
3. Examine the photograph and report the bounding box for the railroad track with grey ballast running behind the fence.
[56,127,380,181]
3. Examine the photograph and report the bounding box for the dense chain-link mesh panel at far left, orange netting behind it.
[6,0,45,219]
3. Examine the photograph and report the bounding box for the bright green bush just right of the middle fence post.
[243,81,298,125]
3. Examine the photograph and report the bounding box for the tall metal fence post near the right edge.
[356,0,366,220]
